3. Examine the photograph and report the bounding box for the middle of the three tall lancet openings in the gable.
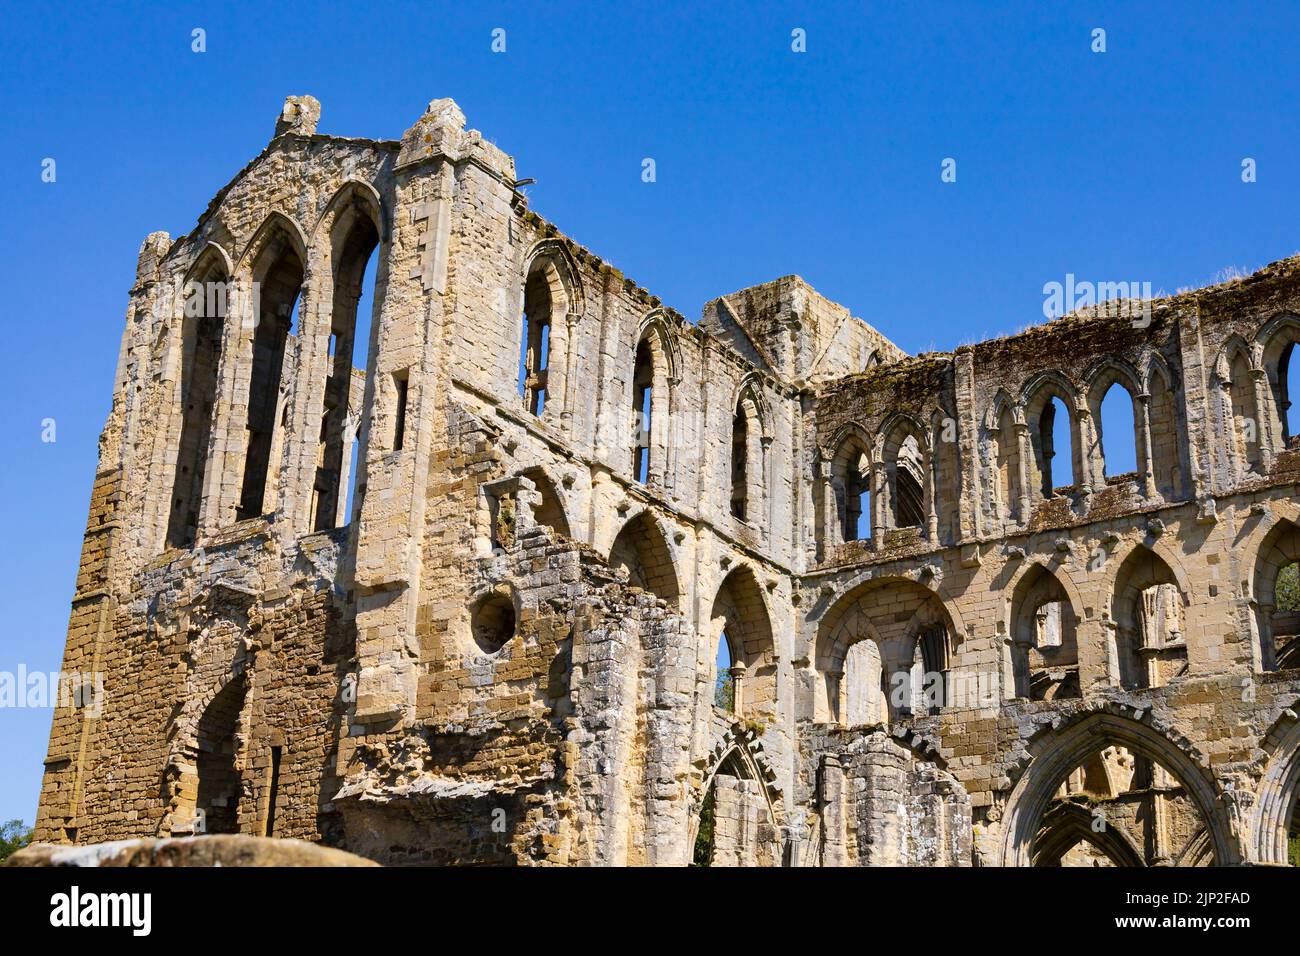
[235,237,303,520]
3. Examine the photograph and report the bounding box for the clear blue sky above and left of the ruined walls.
[0,3,1300,821]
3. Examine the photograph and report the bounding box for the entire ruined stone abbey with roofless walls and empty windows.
[27,96,1300,866]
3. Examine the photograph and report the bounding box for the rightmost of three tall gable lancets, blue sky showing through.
[311,207,380,531]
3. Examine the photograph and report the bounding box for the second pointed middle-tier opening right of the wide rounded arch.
[1113,548,1187,689]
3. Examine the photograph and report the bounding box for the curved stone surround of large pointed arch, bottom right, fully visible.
[998,709,1240,866]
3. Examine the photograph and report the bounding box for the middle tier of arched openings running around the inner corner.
[512,470,1300,726]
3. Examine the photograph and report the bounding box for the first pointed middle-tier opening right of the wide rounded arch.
[1011,566,1080,700]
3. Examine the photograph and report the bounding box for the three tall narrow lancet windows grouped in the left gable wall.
[165,182,382,548]
